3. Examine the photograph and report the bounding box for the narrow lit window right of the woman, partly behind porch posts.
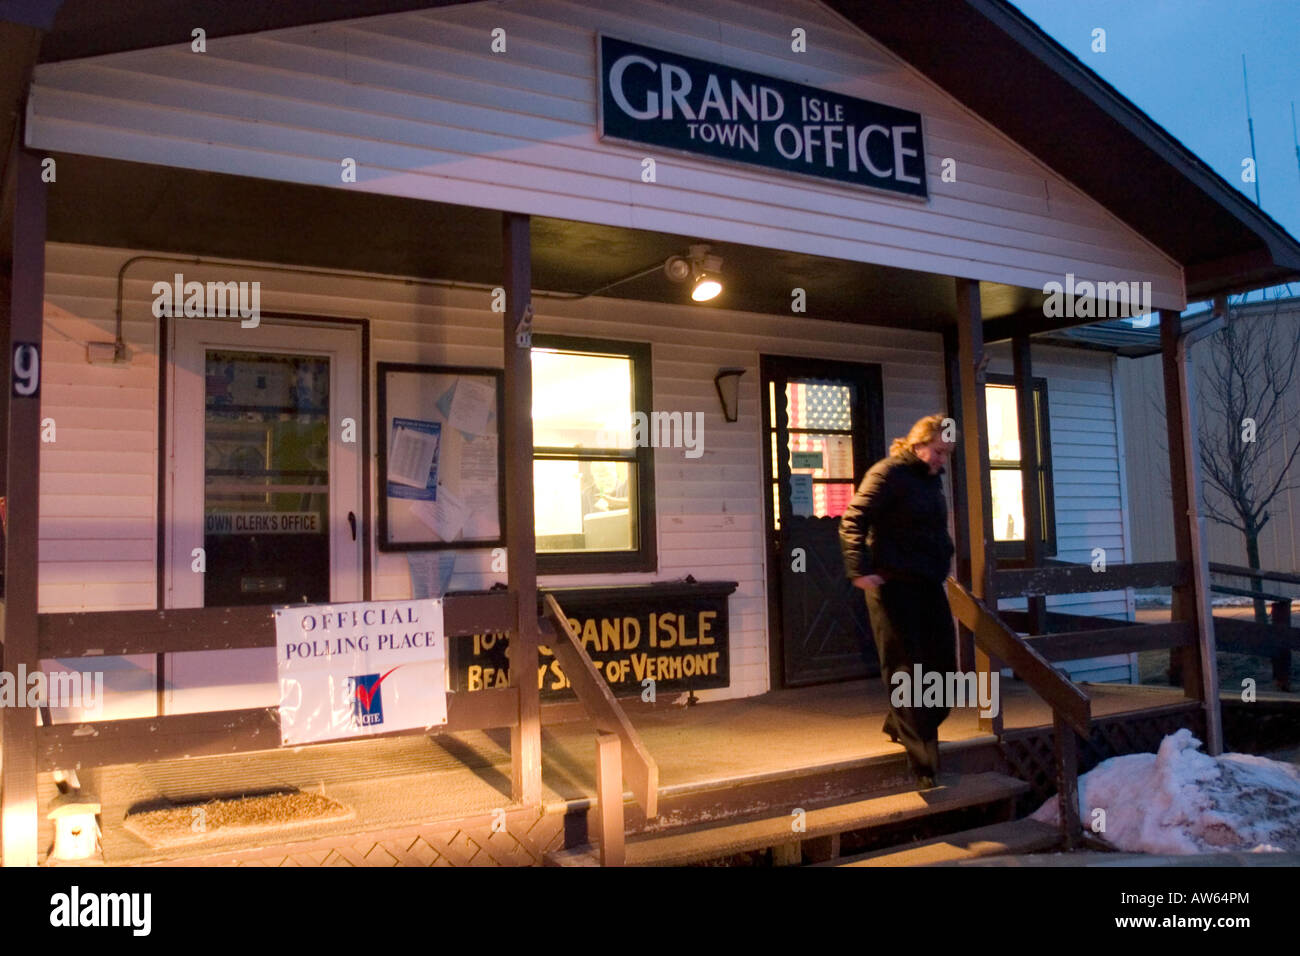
[984,375,1056,558]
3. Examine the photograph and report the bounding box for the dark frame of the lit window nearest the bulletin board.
[529,333,659,575]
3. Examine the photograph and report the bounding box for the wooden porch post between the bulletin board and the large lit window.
[502,212,542,805]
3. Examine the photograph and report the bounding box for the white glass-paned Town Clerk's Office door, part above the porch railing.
[166,319,364,607]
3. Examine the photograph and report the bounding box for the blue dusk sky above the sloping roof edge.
[1013,0,1300,299]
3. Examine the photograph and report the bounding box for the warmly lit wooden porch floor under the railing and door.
[40,679,1216,866]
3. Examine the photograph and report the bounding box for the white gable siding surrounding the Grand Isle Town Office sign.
[27,0,1184,308]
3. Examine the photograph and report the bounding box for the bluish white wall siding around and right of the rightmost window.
[989,345,1131,680]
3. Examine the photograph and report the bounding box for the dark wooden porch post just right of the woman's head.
[957,278,1002,734]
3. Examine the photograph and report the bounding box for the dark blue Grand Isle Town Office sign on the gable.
[598,36,927,198]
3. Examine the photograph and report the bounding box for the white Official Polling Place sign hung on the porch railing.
[276,600,447,745]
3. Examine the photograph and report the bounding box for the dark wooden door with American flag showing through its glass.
[761,355,884,687]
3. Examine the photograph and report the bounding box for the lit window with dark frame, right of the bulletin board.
[533,336,657,574]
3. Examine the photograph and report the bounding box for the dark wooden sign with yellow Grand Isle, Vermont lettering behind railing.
[449,581,736,700]
